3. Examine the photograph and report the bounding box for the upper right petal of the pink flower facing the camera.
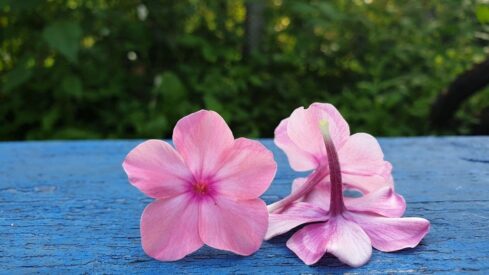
[213,138,277,199]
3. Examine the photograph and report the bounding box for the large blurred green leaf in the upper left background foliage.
[42,21,82,63]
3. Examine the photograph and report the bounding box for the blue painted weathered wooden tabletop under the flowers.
[0,137,489,274]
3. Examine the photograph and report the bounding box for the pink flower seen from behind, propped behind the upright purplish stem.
[269,103,393,213]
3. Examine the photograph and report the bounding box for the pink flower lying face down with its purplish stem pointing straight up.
[265,120,430,267]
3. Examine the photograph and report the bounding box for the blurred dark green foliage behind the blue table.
[0,0,489,140]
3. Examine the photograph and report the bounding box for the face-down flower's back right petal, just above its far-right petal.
[345,187,406,218]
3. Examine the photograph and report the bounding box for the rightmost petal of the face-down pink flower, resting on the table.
[348,212,430,252]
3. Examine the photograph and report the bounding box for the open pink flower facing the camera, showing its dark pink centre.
[123,110,277,261]
